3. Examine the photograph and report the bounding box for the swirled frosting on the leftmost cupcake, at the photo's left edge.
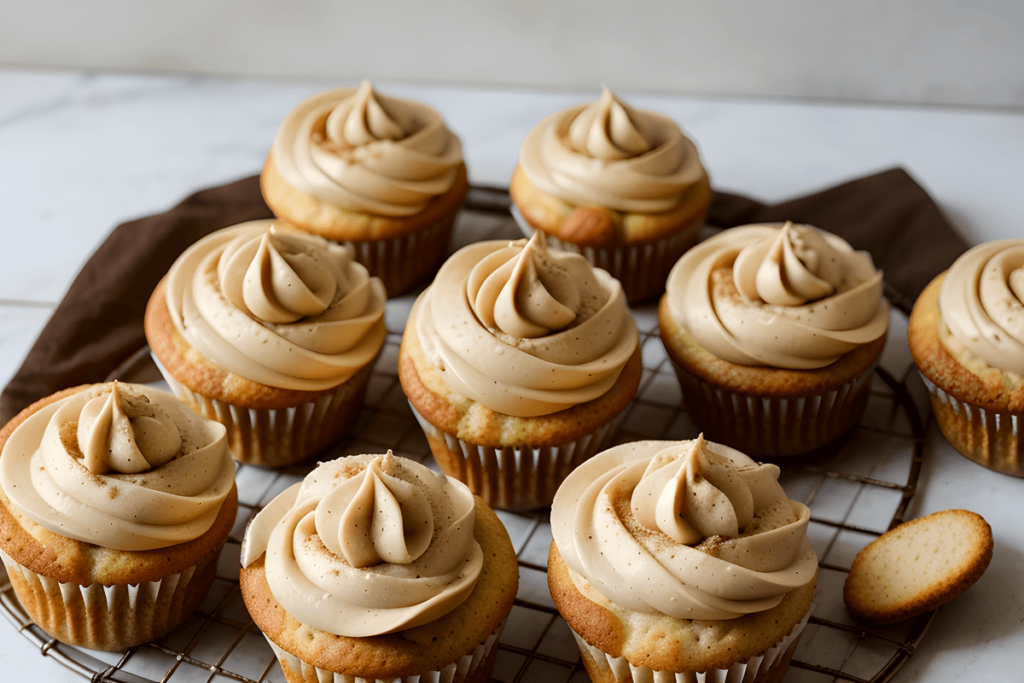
[0,382,234,551]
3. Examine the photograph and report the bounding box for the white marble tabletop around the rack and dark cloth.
[0,69,1024,683]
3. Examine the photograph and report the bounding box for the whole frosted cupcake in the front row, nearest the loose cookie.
[548,436,817,683]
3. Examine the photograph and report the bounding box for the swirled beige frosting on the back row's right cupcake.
[519,88,708,213]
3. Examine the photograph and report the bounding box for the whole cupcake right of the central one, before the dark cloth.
[658,222,889,457]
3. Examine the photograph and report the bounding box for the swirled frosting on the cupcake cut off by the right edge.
[939,240,1024,376]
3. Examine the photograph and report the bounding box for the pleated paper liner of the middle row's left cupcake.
[153,356,372,467]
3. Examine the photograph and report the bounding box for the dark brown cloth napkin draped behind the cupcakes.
[0,168,967,425]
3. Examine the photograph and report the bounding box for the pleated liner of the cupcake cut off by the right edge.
[921,373,1024,476]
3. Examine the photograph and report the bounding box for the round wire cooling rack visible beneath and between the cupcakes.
[0,187,934,683]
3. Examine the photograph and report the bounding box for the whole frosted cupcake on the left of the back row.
[260,81,469,296]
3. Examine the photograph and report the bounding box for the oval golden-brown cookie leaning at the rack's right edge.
[843,510,993,625]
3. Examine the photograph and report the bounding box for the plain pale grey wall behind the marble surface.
[6,0,1024,109]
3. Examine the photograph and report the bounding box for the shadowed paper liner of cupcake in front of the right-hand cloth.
[669,355,879,457]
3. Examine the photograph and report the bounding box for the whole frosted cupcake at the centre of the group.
[398,232,641,510]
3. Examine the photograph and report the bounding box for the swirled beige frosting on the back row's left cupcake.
[273,81,463,216]
